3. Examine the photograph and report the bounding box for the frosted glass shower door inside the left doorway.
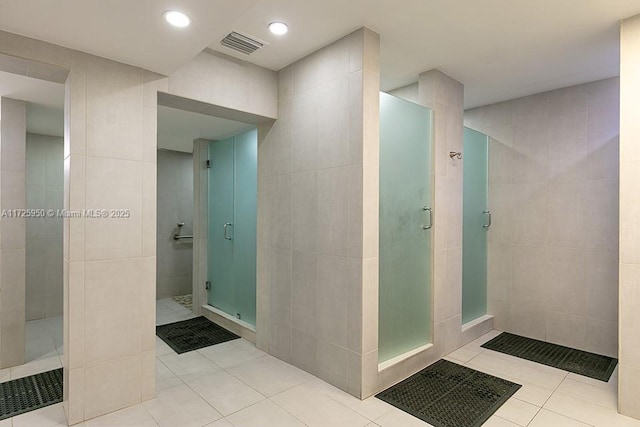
[207,130,258,326]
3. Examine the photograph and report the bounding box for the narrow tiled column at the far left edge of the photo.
[0,98,27,368]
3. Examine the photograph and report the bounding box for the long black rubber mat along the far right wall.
[482,332,618,382]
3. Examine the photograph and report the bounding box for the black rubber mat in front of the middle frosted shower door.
[376,359,522,427]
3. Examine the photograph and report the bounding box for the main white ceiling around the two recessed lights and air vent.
[0,0,640,108]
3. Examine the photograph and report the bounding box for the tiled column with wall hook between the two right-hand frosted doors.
[418,70,464,356]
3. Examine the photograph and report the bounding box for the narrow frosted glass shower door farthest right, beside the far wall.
[462,128,491,323]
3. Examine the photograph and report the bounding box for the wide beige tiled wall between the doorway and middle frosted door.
[257,29,379,396]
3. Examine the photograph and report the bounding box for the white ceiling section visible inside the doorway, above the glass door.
[158,105,255,153]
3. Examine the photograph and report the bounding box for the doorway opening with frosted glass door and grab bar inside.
[156,93,264,354]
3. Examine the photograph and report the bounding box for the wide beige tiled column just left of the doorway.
[63,54,166,424]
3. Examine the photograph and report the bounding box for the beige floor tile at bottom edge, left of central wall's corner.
[271,384,370,427]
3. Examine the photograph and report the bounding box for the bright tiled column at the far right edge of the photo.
[618,15,640,419]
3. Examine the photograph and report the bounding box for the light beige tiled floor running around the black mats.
[0,299,640,427]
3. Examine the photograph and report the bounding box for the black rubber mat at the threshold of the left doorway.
[156,316,240,354]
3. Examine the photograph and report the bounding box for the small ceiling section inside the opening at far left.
[0,71,64,136]
